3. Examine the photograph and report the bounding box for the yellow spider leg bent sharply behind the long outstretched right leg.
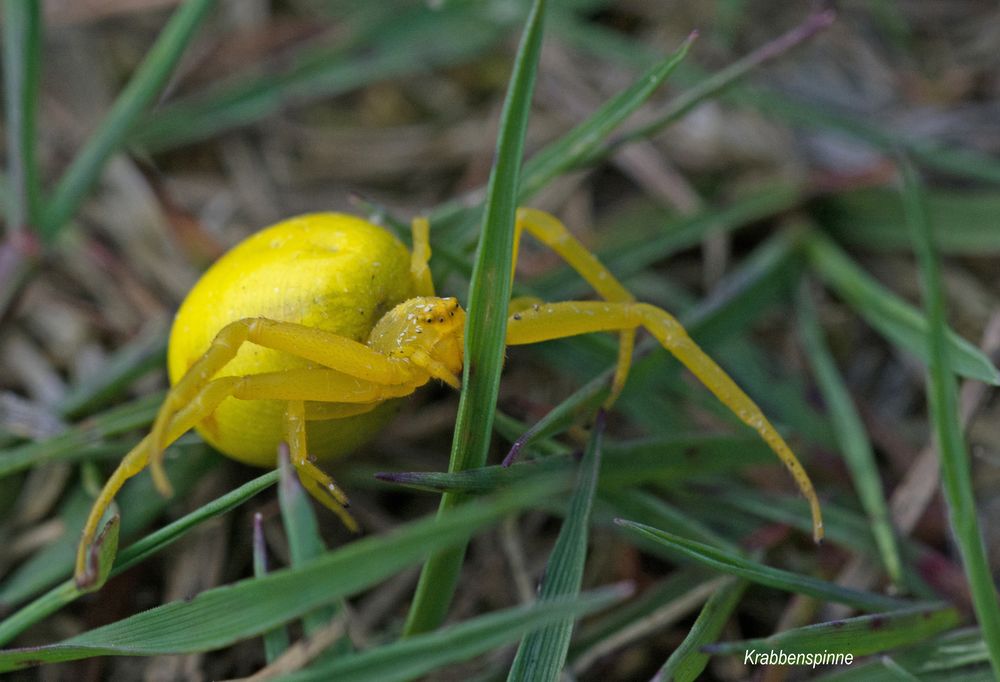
[512,208,635,408]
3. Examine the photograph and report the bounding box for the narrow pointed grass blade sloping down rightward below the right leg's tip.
[615,519,908,612]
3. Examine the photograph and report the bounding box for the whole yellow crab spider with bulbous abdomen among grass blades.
[70,208,823,585]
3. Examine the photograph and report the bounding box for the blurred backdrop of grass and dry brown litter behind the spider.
[0,0,1000,680]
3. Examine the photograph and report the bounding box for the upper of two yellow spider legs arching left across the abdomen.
[150,317,413,494]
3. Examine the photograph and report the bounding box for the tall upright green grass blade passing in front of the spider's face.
[405,0,545,635]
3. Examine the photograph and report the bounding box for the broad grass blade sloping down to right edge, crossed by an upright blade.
[802,231,1000,386]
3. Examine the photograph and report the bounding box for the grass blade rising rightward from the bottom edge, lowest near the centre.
[282,587,631,682]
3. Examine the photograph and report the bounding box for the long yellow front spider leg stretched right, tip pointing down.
[507,301,823,542]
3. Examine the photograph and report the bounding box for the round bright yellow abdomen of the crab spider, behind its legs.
[167,213,414,466]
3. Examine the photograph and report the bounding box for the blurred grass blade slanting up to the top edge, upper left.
[39,0,216,241]
